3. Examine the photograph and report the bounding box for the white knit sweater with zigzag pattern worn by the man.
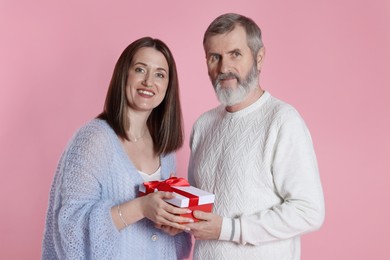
[188,92,324,260]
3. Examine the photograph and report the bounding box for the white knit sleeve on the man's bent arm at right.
[222,116,325,245]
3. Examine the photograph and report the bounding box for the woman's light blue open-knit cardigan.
[42,119,191,260]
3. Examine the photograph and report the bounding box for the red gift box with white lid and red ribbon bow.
[139,177,215,222]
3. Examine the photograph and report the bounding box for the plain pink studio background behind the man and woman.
[0,0,390,260]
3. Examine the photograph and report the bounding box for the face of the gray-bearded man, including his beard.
[205,26,259,106]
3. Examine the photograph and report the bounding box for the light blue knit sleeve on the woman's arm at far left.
[55,127,120,259]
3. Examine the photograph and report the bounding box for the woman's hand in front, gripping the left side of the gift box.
[139,191,193,231]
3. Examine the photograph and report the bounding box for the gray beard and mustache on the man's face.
[213,66,259,106]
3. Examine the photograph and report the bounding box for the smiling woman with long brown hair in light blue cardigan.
[42,37,191,259]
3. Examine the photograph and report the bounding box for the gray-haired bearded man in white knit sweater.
[188,14,324,260]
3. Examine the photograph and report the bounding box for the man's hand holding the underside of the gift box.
[185,210,222,240]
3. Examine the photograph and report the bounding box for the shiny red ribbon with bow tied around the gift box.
[144,177,199,206]
